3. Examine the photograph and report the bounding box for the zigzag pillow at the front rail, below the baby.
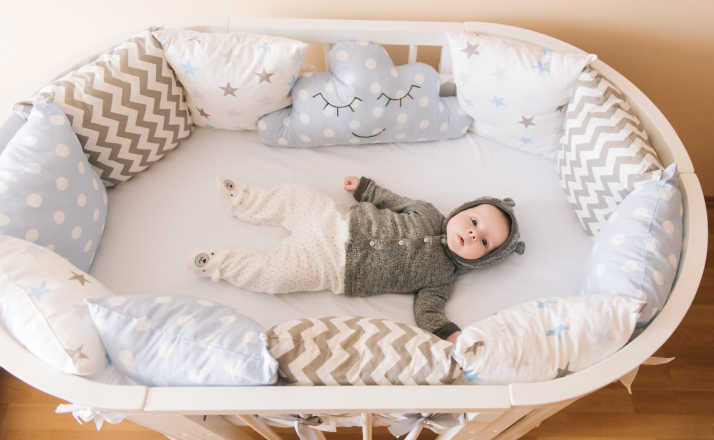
[266,316,462,385]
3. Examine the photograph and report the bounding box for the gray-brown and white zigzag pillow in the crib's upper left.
[35,30,192,186]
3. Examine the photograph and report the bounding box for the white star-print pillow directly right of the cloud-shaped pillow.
[448,32,596,158]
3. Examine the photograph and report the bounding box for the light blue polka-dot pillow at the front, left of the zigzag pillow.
[87,295,278,386]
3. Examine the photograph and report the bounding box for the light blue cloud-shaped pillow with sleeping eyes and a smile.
[258,41,472,147]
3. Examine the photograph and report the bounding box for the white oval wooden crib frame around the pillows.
[0,18,708,439]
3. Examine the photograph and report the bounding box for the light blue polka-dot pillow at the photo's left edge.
[0,101,107,271]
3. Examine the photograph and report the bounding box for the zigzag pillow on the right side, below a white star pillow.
[557,69,663,234]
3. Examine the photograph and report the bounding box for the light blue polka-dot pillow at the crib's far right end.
[583,164,683,327]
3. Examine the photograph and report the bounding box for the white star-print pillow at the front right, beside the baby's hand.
[454,295,642,385]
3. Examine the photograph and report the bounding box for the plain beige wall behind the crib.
[0,0,714,192]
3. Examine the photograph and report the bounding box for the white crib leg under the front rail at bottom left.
[128,414,253,440]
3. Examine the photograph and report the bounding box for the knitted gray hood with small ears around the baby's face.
[442,197,526,272]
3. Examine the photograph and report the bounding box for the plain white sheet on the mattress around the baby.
[91,129,592,327]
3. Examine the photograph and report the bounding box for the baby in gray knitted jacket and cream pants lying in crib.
[191,177,525,342]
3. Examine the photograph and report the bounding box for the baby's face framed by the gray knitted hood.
[446,204,510,260]
